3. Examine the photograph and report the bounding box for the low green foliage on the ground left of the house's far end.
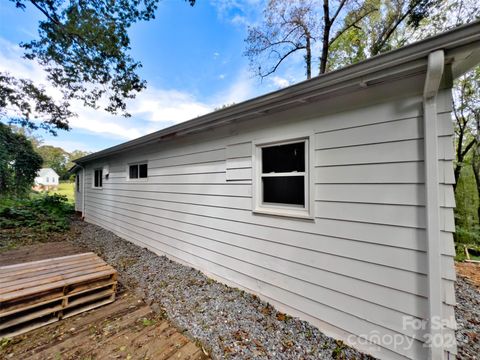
[0,194,74,232]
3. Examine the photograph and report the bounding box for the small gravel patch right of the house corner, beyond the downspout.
[455,276,480,359]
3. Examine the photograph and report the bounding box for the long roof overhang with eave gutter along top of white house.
[75,21,480,165]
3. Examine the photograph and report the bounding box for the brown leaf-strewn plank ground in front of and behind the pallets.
[0,242,206,360]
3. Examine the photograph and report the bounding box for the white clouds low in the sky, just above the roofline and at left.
[0,38,257,140]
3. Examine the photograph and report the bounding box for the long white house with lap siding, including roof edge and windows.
[74,22,480,359]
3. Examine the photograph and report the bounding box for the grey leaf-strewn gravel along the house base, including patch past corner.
[69,221,480,359]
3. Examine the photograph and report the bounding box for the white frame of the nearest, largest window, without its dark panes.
[252,134,315,220]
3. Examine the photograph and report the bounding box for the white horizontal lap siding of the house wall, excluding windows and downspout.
[82,88,455,358]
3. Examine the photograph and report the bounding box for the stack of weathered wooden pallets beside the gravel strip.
[0,253,117,339]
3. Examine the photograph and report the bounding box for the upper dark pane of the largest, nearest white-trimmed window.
[262,141,305,174]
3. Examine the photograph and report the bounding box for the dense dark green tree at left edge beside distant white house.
[0,123,42,196]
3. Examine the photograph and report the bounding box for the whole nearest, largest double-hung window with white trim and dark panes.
[254,138,311,218]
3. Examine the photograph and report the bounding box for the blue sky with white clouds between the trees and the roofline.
[0,0,304,151]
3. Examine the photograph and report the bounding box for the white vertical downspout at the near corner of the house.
[423,50,445,360]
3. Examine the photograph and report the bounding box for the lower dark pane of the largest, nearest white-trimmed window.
[263,176,305,206]
